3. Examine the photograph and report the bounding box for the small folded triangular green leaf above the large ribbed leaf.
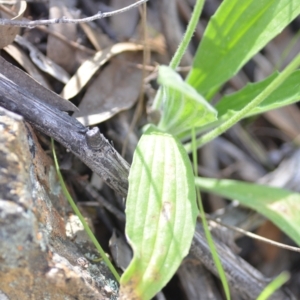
[158,66,217,136]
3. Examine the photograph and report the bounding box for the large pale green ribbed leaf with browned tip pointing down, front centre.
[120,126,198,299]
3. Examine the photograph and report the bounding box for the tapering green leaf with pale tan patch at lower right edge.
[195,177,300,245]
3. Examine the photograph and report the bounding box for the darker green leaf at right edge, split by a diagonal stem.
[215,71,300,118]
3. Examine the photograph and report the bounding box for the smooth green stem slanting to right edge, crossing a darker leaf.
[185,54,300,152]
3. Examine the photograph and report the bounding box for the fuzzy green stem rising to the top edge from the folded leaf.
[152,0,204,110]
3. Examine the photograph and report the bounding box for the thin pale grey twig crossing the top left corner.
[0,0,148,28]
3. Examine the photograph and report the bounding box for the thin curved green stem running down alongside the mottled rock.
[51,139,120,282]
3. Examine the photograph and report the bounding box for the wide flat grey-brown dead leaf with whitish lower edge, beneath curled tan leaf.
[74,53,142,126]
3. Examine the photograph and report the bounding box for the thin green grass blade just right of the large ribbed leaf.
[192,128,231,300]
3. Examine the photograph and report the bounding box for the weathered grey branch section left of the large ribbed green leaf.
[0,57,129,197]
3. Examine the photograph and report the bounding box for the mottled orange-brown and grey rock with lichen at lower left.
[0,108,118,300]
